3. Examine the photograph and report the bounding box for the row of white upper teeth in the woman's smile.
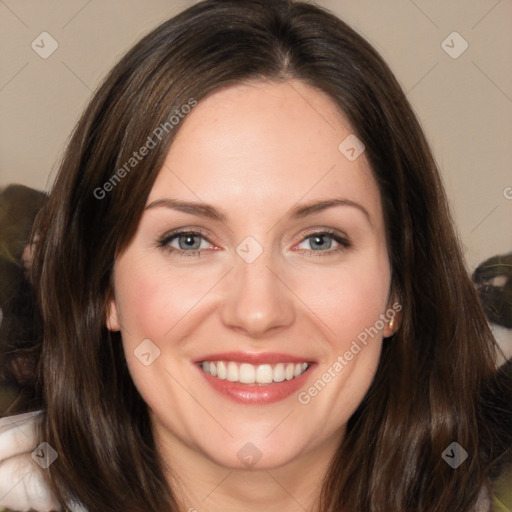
[201,361,309,384]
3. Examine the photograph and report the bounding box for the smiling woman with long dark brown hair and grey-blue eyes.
[1,0,508,512]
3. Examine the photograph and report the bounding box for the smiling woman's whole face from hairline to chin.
[108,80,394,468]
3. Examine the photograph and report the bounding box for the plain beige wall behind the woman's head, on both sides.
[0,0,512,269]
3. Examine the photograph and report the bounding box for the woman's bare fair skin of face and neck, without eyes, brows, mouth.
[108,80,397,512]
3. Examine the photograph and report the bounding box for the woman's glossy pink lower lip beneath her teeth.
[195,363,315,405]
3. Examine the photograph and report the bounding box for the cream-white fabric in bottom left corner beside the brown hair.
[0,411,61,512]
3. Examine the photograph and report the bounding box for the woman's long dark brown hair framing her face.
[29,0,508,512]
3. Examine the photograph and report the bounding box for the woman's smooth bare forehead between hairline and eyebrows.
[148,80,381,229]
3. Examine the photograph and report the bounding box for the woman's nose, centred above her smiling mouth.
[220,252,296,338]
